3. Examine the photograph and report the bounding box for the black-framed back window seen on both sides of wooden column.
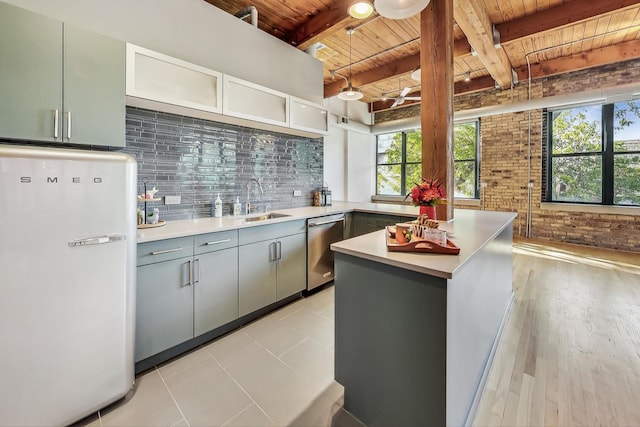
[376,121,479,198]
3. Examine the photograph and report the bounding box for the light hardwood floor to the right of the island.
[474,240,640,426]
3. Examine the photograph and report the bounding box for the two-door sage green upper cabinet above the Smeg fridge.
[0,3,125,147]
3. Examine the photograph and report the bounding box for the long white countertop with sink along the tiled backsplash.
[136,202,418,243]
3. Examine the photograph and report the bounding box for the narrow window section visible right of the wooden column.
[453,121,479,199]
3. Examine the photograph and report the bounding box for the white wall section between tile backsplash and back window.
[324,97,376,202]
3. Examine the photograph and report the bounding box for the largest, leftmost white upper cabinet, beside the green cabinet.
[127,44,222,113]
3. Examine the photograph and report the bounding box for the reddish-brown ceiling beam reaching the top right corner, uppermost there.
[496,0,638,43]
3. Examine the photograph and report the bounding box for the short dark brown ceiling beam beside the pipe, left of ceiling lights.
[285,0,353,49]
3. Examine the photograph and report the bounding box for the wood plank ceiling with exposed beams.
[204,0,640,110]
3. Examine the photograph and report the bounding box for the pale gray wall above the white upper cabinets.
[4,0,324,104]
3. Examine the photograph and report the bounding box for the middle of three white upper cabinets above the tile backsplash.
[222,74,289,127]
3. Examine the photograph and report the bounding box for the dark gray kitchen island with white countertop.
[331,210,516,426]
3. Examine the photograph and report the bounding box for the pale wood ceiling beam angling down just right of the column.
[453,0,512,89]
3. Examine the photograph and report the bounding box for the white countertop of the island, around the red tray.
[331,209,517,279]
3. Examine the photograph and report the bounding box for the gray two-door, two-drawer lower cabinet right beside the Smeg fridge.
[135,230,238,362]
